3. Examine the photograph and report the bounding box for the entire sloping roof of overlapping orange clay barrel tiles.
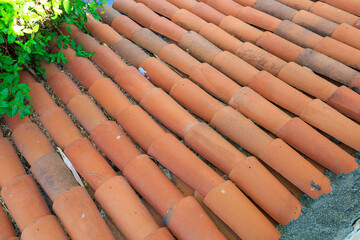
[0,0,360,240]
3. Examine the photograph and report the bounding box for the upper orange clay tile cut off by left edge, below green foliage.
[0,137,25,186]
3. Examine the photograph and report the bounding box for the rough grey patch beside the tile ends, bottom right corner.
[278,156,360,240]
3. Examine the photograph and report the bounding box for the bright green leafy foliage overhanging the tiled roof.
[0,0,106,118]
